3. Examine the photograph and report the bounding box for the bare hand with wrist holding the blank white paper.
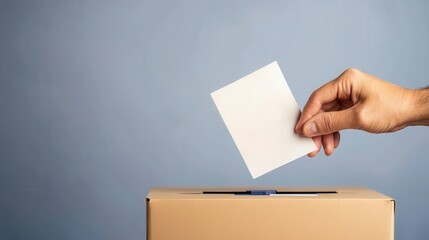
[295,68,429,157]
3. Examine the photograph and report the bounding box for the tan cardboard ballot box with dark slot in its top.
[146,187,395,240]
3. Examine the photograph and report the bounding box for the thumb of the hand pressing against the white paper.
[302,108,354,137]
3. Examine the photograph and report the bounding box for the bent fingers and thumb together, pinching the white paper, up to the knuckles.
[295,68,362,157]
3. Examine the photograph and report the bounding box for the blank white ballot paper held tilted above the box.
[211,62,317,178]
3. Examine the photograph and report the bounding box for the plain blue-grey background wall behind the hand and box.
[0,0,429,239]
